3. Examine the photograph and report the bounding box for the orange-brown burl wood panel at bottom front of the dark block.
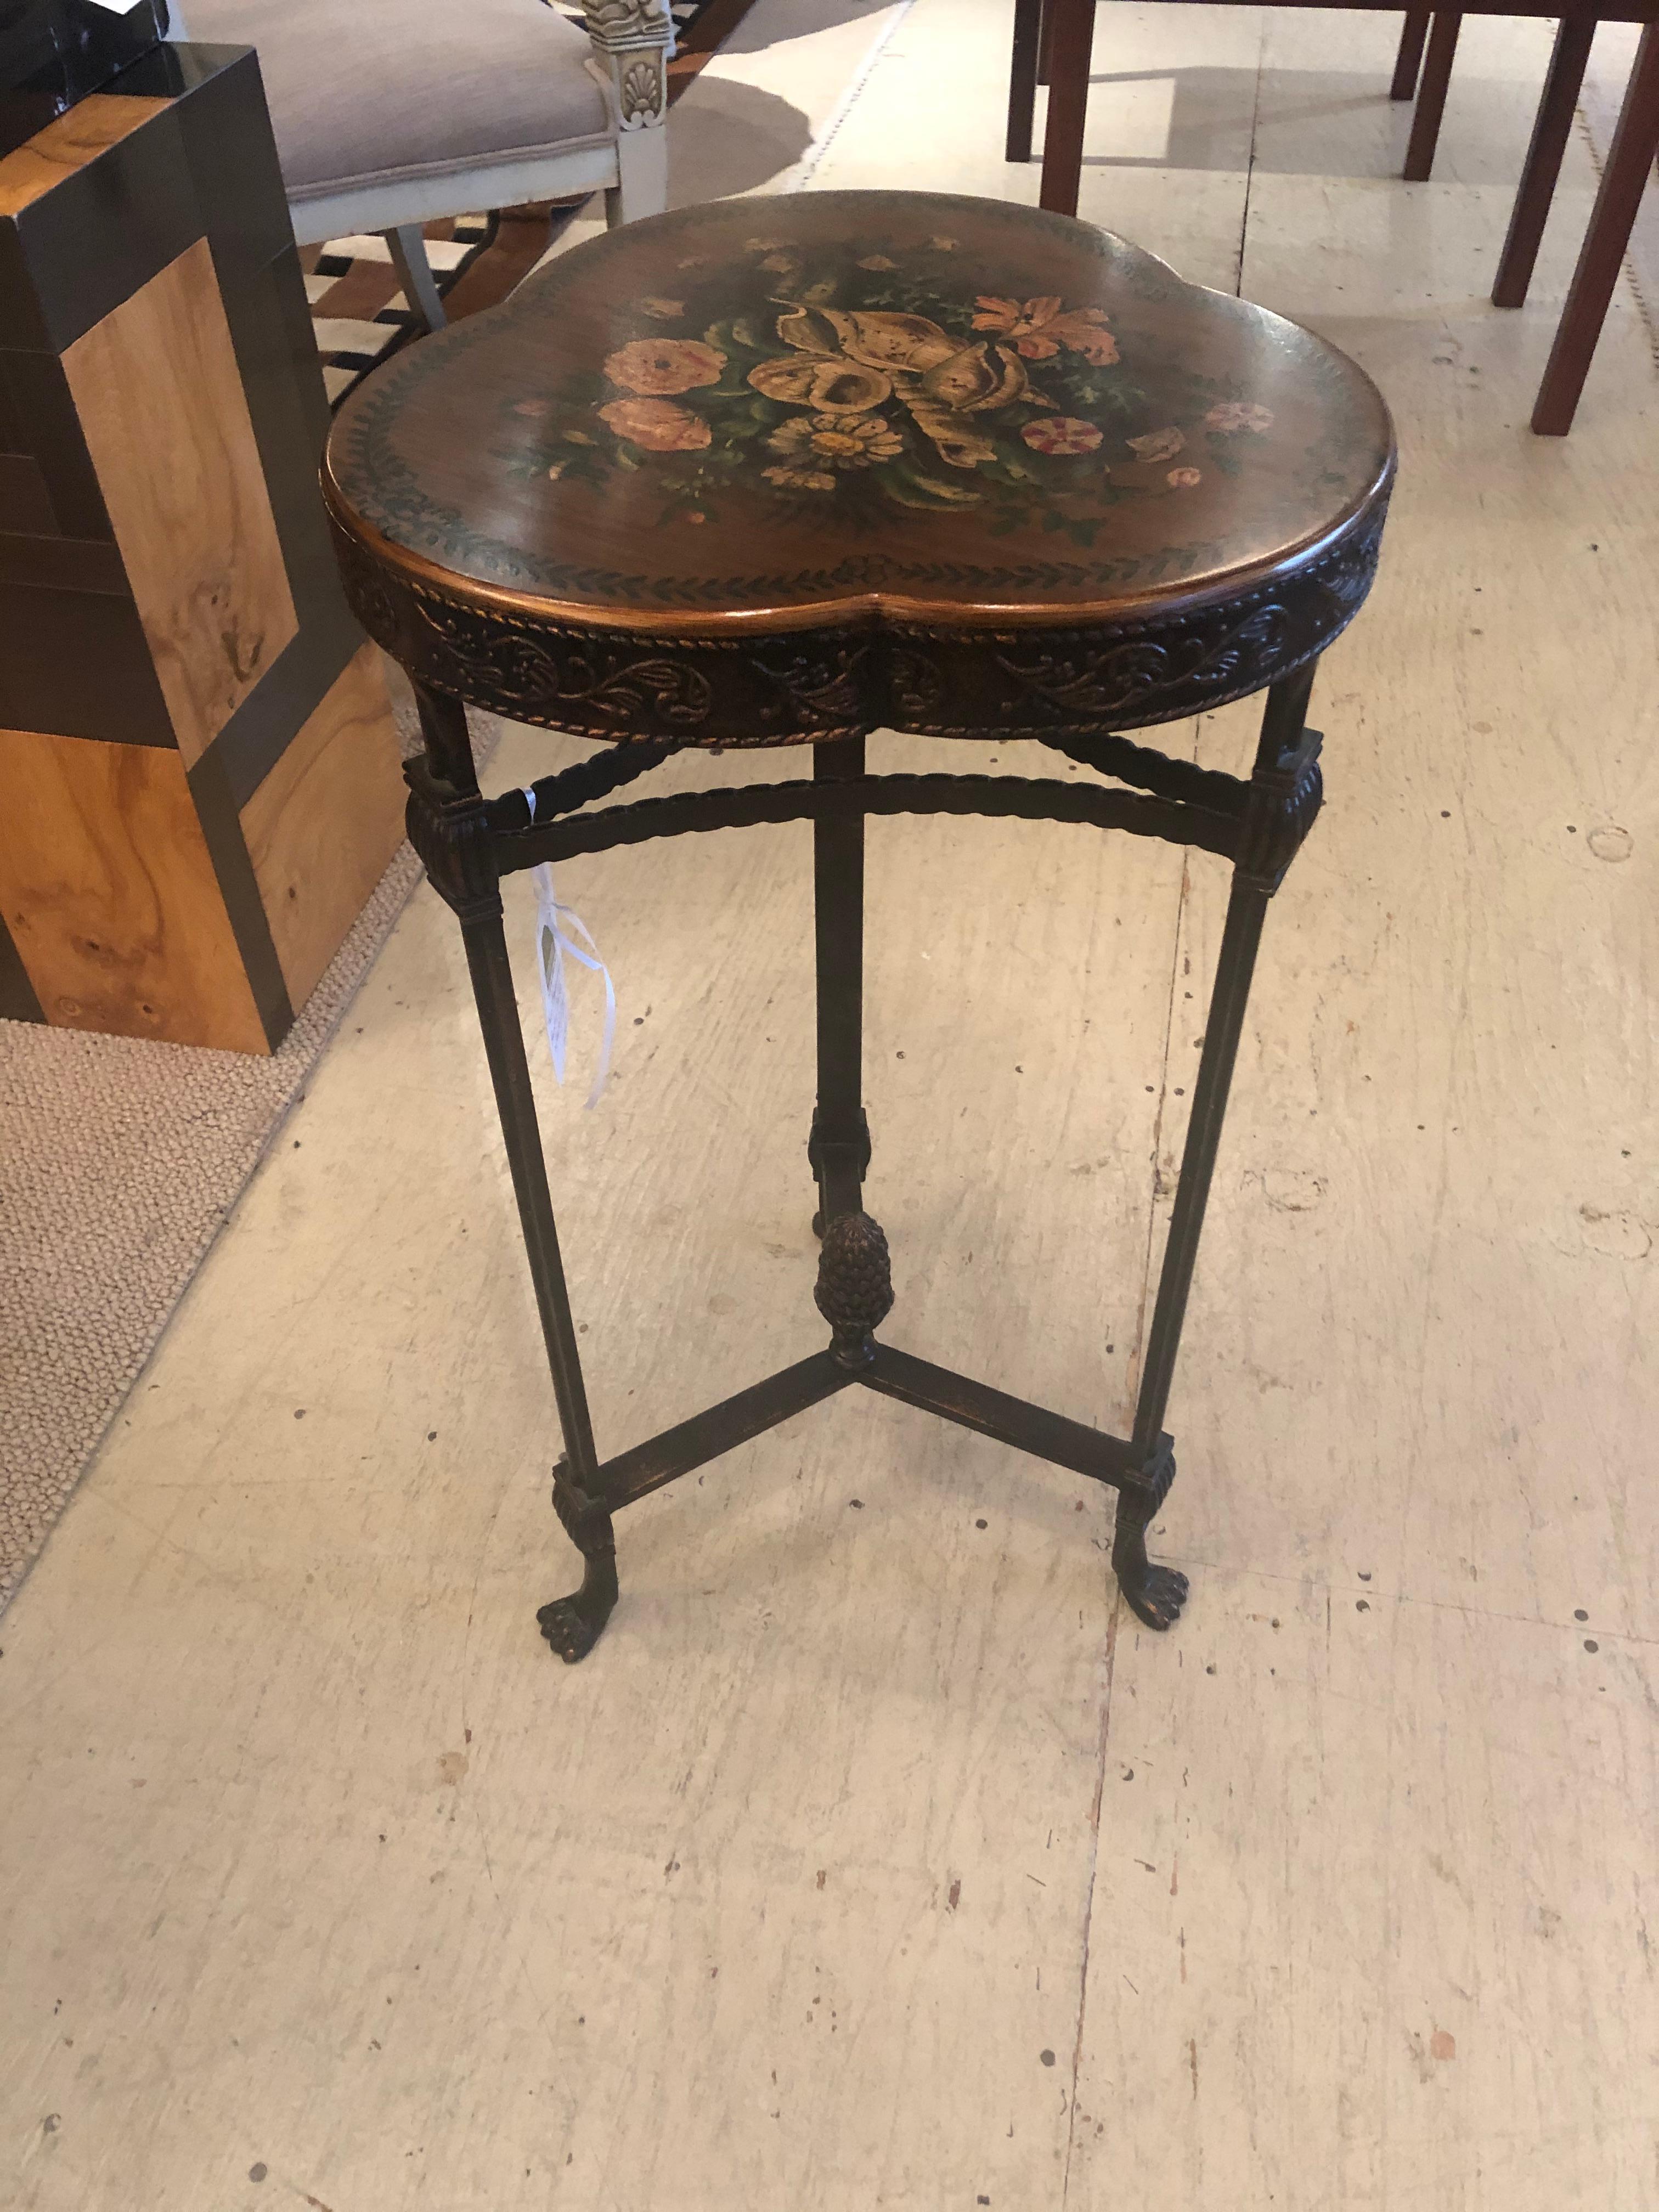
[0,730,268,1053]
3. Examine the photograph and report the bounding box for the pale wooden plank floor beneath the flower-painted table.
[0,0,1659,2212]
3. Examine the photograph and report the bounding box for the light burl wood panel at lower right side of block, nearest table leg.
[241,646,403,1013]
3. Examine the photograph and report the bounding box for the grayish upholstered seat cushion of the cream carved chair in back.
[182,0,613,201]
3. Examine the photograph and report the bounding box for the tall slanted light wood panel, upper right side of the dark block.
[64,239,298,765]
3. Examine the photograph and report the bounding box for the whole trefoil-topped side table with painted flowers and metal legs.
[325,193,1393,1661]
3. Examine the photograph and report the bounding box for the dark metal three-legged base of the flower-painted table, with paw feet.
[407,664,1321,1659]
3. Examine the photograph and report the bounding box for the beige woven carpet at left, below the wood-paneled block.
[0,712,506,1606]
